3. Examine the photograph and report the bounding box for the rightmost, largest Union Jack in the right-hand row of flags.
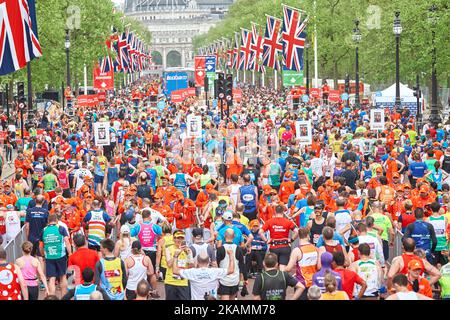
[281,5,308,71]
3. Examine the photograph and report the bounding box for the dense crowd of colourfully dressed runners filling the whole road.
[0,78,450,300]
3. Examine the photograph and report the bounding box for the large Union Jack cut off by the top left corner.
[0,0,42,75]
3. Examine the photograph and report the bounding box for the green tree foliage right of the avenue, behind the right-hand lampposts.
[194,0,450,87]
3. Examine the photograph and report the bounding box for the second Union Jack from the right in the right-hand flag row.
[263,16,283,70]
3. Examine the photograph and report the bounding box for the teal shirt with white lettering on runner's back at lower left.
[41,224,69,260]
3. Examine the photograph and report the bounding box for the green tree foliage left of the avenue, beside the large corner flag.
[1,0,151,92]
